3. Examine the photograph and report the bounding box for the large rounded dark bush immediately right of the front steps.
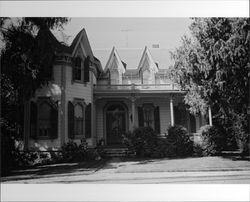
[130,127,157,157]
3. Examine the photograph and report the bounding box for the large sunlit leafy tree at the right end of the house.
[171,18,250,152]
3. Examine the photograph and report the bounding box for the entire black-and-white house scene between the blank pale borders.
[0,0,250,201]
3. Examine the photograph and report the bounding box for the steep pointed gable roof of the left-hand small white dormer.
[104,47,126,73]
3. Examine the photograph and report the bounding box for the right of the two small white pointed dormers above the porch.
[138,46,159,84]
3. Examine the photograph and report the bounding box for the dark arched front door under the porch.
[106,104,126,145]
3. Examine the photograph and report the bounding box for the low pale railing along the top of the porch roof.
[94,83,180,90]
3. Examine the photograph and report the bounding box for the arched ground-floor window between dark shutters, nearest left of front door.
[74,104,83,136]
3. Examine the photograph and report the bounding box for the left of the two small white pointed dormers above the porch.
[104,47,126,84]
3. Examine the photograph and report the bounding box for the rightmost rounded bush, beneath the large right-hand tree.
[198,125,225,156]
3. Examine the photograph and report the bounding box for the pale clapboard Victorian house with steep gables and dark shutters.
[24,29,211,150]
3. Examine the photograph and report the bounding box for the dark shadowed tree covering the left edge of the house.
[0,18,69,174]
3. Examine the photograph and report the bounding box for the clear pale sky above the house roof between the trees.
[63,18,191,50]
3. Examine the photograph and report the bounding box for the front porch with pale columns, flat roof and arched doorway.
[94,84,207,147]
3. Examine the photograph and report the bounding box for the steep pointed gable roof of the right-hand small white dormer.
[138,46,159,72]
